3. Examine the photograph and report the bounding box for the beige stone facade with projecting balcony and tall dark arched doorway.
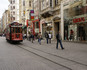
[40,0,62,39]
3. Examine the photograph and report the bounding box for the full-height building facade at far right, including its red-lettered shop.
[62,0,87,41]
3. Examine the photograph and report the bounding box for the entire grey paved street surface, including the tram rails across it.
[0,38,87,70]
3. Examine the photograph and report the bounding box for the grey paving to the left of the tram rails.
[0,37,69,70]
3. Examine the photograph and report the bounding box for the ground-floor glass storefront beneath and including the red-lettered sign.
[64,15,87,41]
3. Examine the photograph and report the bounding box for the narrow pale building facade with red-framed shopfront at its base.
[32,0,41,34]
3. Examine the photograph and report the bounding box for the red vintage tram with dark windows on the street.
[6,22,23,42]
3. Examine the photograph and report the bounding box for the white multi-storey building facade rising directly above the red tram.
[9,0,19,22]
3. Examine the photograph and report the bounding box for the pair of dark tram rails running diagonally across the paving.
[14,44,87,70]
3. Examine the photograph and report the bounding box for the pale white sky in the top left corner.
[0,0,9,18]
